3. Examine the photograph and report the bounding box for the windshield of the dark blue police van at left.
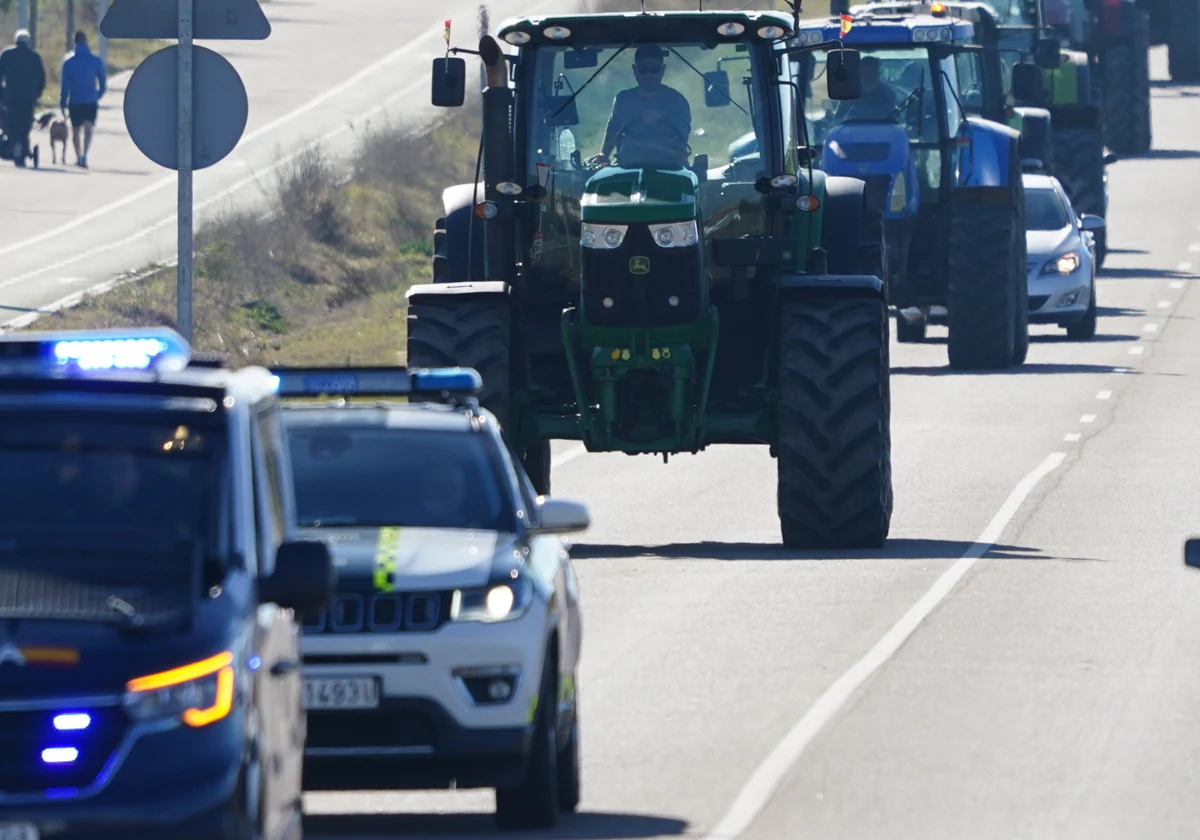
[0,410,227,620]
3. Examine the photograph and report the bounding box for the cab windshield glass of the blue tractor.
[798,44,962,202]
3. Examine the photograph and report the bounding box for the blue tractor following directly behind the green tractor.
[787,13,1030,370]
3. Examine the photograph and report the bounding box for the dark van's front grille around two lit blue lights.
[0,707,128,794]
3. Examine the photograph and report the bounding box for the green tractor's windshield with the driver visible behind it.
[520,42,778,282]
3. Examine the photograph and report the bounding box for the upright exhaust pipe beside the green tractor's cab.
[479,35,516,283]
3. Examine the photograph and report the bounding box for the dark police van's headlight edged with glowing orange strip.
[121,650,234,727]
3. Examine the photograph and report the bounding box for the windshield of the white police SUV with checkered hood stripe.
[288,424,515,532]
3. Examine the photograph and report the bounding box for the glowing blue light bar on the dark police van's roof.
[0,328,192,373]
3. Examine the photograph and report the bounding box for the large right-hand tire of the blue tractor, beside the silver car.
[947,195,1028,370]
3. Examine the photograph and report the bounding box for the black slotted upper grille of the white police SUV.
[304,590,454,635]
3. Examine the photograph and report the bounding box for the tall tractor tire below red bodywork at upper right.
[1103,8,1152,155]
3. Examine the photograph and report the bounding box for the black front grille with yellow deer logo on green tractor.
[582,224,704,328]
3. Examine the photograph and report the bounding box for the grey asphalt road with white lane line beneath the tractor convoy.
[307,44,1200,840]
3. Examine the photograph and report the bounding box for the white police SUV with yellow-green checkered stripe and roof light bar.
[275,368,589,829]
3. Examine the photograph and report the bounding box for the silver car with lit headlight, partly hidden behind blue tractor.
[1022,174,1105,340]
